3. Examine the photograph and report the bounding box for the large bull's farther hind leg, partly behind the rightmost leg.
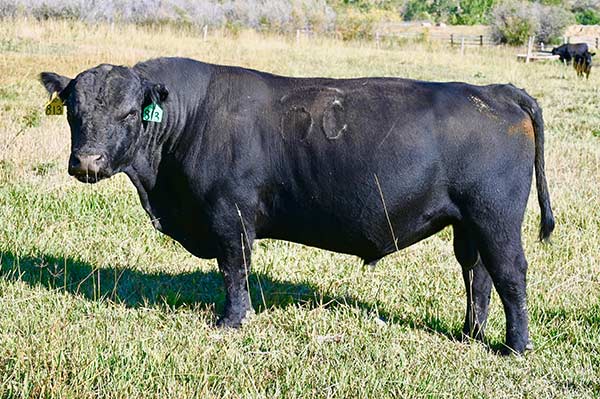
[454,225,492,341]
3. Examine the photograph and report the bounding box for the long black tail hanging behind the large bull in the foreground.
[519,92,554,241]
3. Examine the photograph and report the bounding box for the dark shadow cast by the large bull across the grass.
[0,252,461,340]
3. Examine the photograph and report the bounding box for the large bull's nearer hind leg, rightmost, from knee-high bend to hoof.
[478,228,531,353]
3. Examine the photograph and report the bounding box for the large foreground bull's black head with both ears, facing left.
[40,65,168,183]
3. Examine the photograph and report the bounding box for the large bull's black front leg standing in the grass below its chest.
[217,234,254,328]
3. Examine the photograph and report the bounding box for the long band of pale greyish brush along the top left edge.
[0,0,335,31]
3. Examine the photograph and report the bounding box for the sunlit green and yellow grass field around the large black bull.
[0,20,600,399]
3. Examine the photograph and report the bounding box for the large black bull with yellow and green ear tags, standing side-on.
[41,58,554,352]
